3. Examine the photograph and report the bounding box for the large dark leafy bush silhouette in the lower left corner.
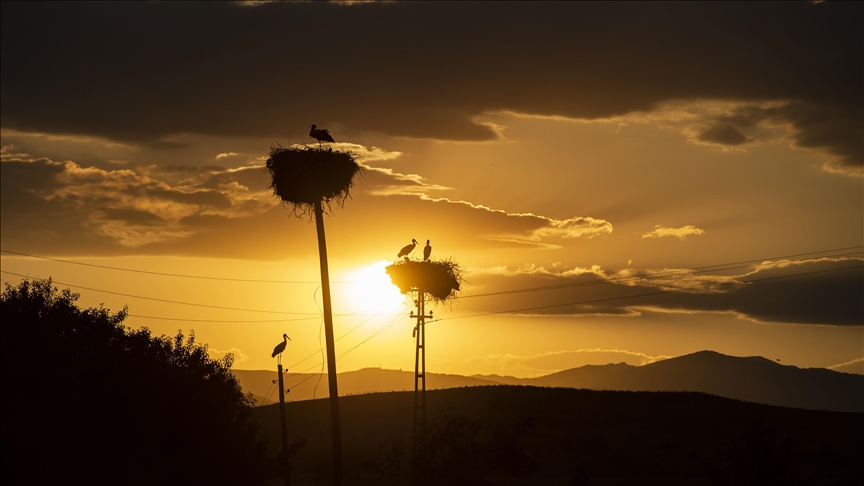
[0,278,271,485]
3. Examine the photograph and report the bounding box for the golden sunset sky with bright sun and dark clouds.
[0,2,864,378]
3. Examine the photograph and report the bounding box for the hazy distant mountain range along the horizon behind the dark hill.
[234,351,864,413]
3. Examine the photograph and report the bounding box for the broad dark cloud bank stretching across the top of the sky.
[0,2,864,167]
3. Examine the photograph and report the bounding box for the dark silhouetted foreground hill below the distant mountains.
[256,386,864,486]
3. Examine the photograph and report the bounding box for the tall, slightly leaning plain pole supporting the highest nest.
[315,201,342,486]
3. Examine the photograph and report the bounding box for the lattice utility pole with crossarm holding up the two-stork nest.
[410,289,432,484]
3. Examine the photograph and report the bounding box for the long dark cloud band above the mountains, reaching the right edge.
[461,259,864,326]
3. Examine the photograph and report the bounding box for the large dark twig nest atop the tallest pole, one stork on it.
[266,144,363,216]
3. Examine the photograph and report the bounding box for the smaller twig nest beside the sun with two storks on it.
[384,260,462,303]
